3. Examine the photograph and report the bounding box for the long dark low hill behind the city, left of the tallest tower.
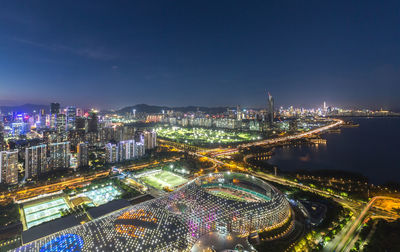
[116,104,228,114]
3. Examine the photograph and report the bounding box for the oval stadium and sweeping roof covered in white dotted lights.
[16,172,292,251]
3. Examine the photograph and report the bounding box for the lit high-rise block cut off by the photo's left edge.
[0,150,18,185]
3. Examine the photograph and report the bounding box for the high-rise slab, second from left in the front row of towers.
[25,144,49,178]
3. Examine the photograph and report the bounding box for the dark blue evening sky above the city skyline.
[0,0,400,109]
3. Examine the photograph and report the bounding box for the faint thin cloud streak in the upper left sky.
[13,38,117,60]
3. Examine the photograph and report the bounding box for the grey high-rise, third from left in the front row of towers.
[48,142,70,170]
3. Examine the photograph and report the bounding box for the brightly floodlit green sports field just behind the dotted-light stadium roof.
[140,171,187,189]
